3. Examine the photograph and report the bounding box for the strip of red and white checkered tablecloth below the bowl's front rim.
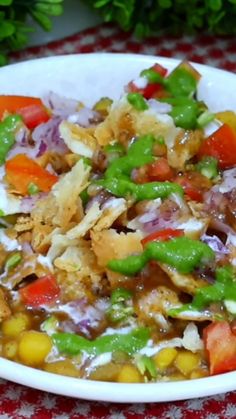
[0,380,236,419]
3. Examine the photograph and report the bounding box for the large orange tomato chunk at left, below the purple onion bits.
[5,154,58,195]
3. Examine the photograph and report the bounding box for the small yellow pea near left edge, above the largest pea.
[2,313,30,338]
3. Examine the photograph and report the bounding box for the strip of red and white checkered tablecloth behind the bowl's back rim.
[11,24,236,73]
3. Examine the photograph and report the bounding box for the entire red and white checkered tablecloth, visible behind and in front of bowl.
[0,25,236,419]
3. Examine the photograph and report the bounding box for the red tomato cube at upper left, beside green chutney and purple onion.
[17,105,50,129]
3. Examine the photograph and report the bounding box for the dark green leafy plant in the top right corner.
[88,0,236,37]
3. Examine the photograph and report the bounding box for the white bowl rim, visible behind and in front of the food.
[0,54,236,403]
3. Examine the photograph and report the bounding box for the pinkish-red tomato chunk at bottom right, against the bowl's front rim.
[203,321,236,375]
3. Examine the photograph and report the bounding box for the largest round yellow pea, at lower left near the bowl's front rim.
[18,330,52,366]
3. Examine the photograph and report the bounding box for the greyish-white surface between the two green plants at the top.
[29,0,101,45]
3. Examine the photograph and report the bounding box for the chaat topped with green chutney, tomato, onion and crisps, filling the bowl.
[0,57,236,383]
